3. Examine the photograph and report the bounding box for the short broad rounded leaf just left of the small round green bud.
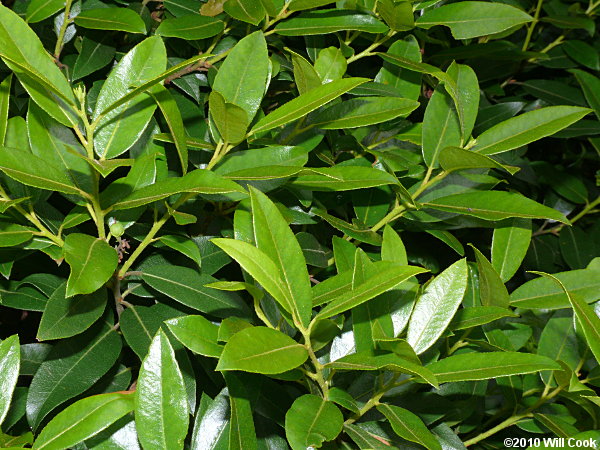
[64,233,119,297]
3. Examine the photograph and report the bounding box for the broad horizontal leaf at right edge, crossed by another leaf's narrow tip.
[510,269,600,309]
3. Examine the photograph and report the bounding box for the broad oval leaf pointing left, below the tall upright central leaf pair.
[217,327,308,374]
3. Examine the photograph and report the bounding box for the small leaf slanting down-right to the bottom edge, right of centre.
[377,403,442,450]
